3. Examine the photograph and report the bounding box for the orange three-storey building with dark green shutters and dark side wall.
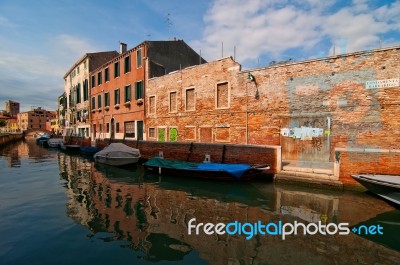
[90,40,205,140]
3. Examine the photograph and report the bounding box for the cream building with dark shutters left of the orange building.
[63,51,118,137]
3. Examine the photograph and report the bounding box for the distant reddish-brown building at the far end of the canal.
[17,107,57,131]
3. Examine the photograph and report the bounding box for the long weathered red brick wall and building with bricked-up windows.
[146,47,400,182]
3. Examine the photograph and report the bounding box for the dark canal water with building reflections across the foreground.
[0,140,400,265]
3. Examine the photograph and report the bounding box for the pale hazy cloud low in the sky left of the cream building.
[0,34,99,110]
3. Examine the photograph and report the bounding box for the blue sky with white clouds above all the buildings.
[0,0,400,111]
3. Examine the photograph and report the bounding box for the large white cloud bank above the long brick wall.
[192,0,400,65]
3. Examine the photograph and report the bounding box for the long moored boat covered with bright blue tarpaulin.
[143,157,270,180]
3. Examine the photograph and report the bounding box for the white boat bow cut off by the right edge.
[352,174,400,205]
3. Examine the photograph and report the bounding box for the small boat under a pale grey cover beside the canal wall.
[94,143,140,166]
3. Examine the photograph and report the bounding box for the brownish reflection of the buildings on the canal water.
[58,153,400,264]
